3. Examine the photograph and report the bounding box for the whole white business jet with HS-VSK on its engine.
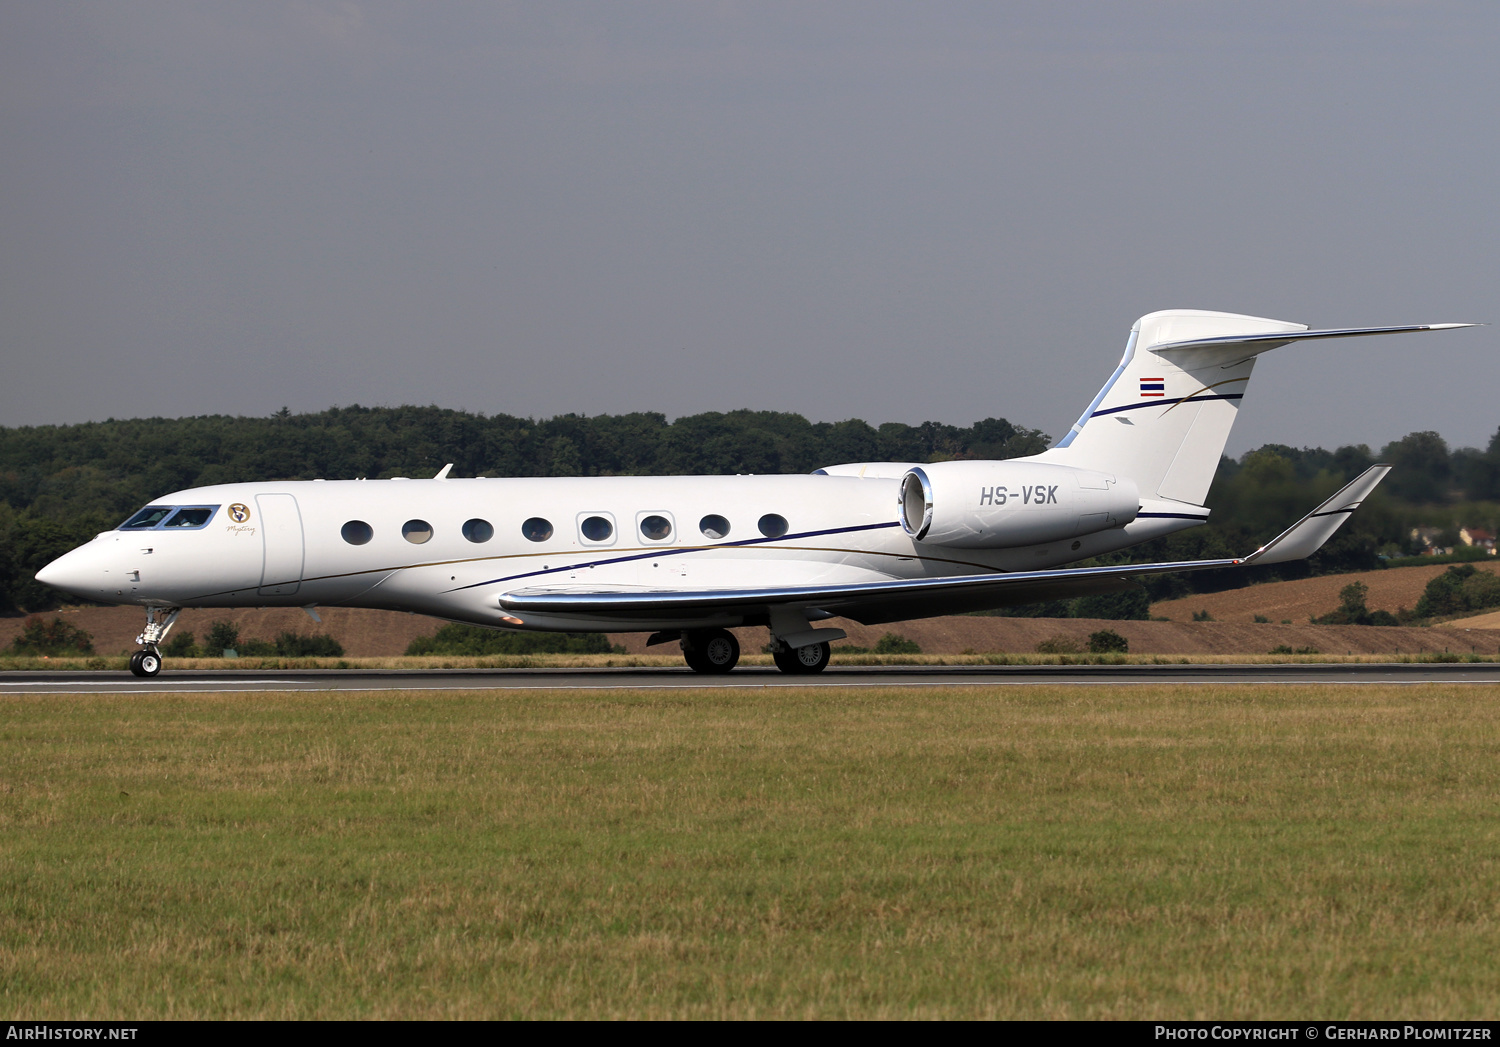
[36,309,1473,677]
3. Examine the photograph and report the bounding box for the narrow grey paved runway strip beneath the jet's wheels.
[0,663,1500,695]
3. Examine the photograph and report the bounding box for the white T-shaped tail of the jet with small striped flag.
[1041,309,1473,506]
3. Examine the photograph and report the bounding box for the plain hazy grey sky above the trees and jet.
[0,0,1500,453]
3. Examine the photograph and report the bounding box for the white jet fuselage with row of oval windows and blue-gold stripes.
[44,476,1199,630]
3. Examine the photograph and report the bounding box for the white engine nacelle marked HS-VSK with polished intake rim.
[900,462,1140,549]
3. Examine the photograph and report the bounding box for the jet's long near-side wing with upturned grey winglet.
[500,465,1391,626]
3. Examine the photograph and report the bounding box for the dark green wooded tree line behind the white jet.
[0,405,1500,614]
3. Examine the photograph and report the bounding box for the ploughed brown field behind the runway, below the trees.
[0,566,1500,657]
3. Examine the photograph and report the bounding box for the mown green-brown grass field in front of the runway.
[0,686,1500,1019]
